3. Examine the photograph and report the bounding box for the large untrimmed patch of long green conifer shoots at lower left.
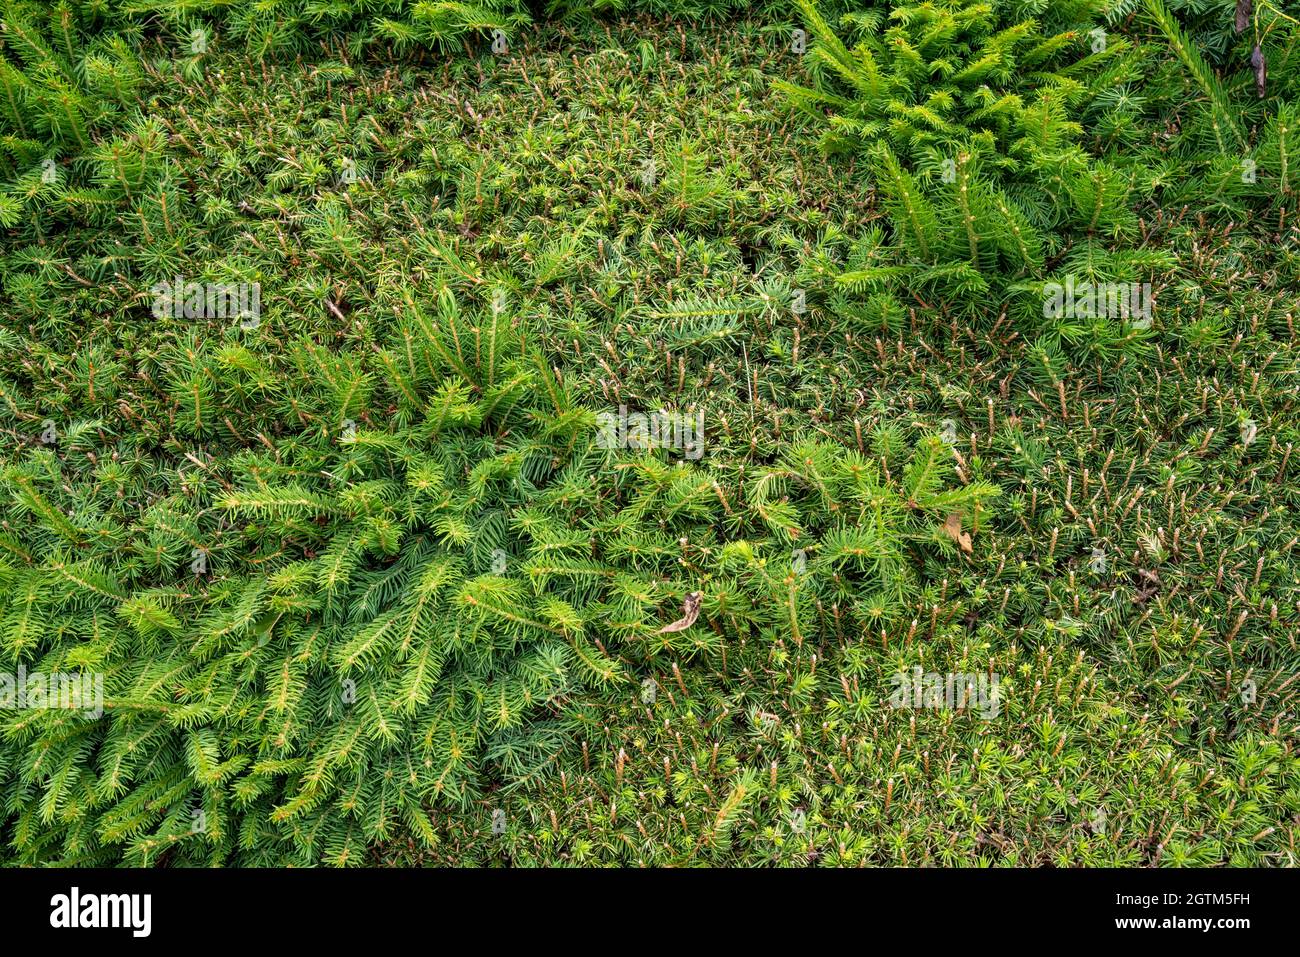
[0,252,997,865]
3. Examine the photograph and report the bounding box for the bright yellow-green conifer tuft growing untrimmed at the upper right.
[780,0,1139,299]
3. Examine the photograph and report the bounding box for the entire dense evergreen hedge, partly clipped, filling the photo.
[0,0,1300,865]
